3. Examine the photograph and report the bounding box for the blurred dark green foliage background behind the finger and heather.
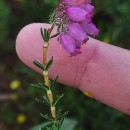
[0,0,130,130]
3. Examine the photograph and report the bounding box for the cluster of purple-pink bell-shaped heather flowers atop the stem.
[55,0,99,55]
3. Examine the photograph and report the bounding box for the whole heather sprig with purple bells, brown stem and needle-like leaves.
[31,0,99,130]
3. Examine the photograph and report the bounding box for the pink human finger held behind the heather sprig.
[16,23,130,115]
